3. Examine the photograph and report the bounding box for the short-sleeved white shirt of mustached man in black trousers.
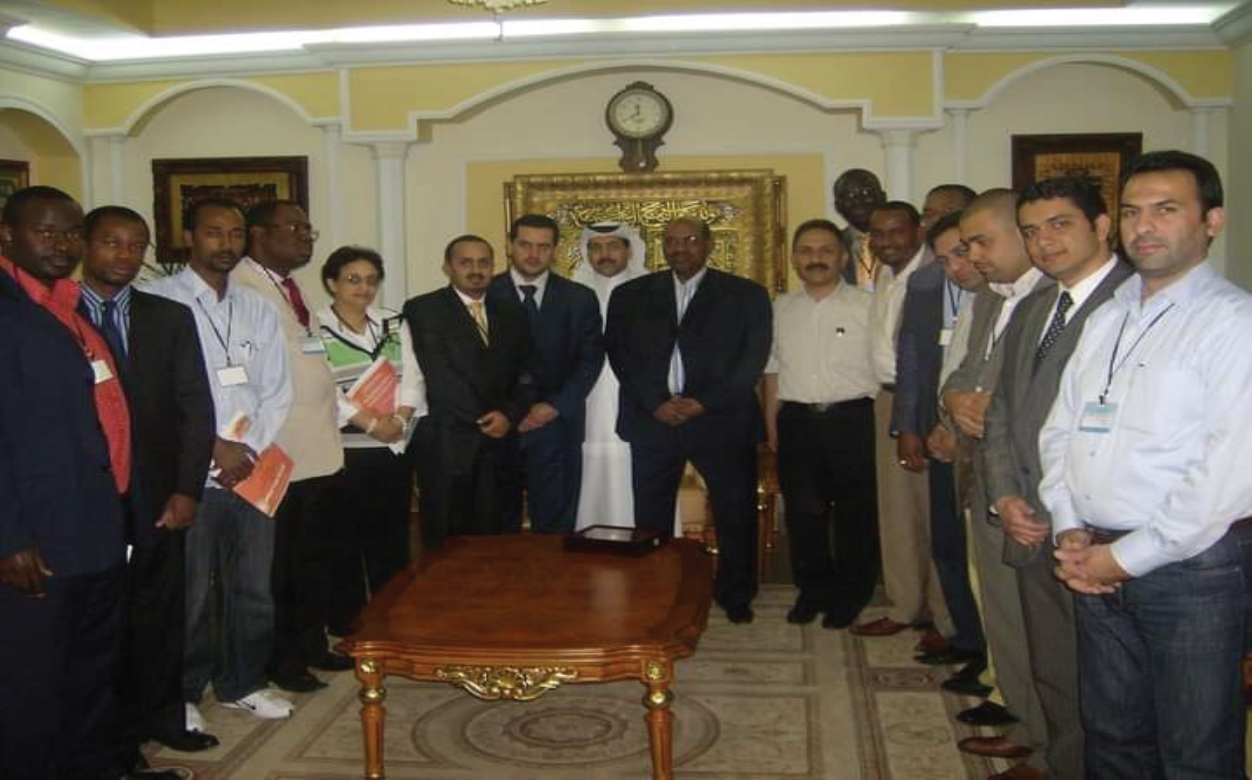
[765,282,879,403]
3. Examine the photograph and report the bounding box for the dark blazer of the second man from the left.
[123,288,217,545]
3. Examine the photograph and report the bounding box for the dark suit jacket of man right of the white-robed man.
[605,268,772,446]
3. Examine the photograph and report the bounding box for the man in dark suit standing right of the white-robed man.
[605,218,772,622]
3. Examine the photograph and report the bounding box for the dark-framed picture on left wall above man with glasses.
[153,157,309,265]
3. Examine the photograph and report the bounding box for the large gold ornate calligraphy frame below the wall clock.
[505,170,788,293]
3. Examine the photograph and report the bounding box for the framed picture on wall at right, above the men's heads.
[1013,133,1143,223]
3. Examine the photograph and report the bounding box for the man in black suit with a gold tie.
[404,235,533,548]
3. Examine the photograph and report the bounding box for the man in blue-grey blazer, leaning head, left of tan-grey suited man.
[891,213,985,665]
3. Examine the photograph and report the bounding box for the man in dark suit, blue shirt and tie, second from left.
[79,205,218,766]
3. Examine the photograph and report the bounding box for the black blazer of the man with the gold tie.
[404,285,536,473]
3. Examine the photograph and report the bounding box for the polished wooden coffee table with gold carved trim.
[338,535,712,779]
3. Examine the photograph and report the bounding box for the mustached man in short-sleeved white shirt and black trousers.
[762,219,879,629]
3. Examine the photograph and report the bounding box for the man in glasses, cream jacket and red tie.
[232,200,352,692]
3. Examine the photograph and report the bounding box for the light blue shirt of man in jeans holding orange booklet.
[140,268,292,475]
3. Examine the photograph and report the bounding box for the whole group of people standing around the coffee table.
[0,143,1252,780]
